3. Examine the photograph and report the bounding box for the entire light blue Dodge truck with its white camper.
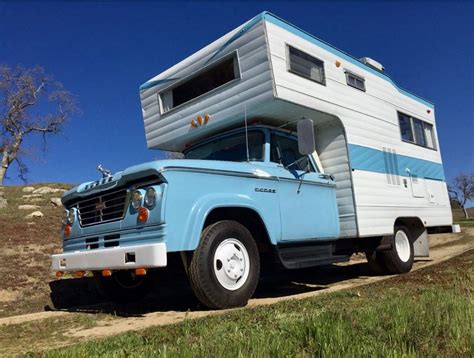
[52,12,452,308]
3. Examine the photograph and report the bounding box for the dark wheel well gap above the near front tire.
[203,207,271,252]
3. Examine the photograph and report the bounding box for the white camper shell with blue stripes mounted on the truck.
[140,12,452,238]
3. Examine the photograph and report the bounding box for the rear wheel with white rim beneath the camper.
[381,226,414,274]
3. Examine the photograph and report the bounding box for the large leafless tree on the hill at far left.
[0,64,77,186]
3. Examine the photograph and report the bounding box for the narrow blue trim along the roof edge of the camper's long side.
[257,12,434,108]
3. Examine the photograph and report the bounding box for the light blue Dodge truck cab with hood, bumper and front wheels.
[53,123,339,308]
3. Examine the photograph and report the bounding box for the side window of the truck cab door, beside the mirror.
[270,134,315,172]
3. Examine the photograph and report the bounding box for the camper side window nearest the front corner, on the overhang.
[287,46,326,85]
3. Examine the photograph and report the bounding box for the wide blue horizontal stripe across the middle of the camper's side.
[349,144,445,181]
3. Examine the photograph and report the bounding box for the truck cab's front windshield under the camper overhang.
[184,130,265,162]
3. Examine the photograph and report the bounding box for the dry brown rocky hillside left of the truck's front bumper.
[0,184,104,317]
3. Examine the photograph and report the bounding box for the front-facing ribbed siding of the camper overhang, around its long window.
[140,19,273,151]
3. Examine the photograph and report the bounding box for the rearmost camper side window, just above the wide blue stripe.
[398,112,436,149]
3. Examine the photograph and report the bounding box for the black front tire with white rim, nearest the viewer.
[188,220,260,309]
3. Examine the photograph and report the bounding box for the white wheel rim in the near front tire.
[214,238,250,291]
